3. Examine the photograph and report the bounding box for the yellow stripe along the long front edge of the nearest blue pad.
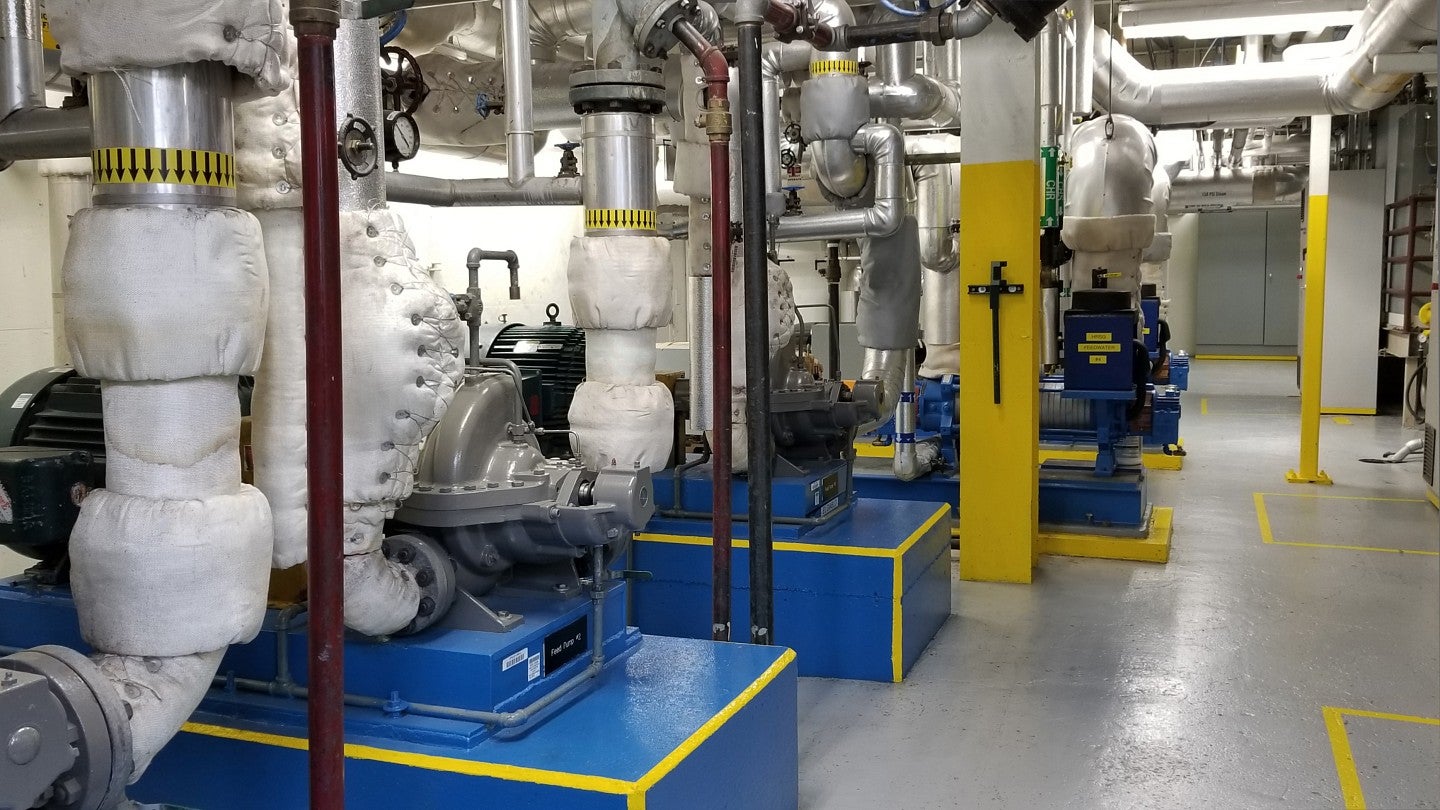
[181,722,638,796]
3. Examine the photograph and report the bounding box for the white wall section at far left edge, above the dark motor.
[0,161,55,389]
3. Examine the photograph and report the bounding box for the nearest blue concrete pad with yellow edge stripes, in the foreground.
[0,581,799,810]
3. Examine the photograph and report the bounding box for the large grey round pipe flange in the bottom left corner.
[0,646,135,810]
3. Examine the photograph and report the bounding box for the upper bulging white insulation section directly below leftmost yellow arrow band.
[63,206,268,382]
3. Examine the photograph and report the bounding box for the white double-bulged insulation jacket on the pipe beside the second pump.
[569,235,675,471]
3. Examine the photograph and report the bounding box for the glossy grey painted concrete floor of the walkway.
[801,362,1440,810]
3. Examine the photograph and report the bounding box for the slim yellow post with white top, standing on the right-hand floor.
[1284,115,1333,484]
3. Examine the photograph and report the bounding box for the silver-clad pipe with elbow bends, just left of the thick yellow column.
[771,124,906,242]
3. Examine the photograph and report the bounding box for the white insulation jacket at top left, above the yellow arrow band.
[45,0,294,92]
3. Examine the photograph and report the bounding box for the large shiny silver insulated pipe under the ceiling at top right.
[1093,0,1436,128]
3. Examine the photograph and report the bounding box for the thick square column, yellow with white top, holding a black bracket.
[959,25,1041,582]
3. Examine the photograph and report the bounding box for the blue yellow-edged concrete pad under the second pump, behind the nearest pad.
[631,499,952,682]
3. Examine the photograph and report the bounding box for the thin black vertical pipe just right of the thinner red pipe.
[737,18,777,644]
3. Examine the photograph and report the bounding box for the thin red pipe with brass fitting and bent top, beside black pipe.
[671,20,733,641]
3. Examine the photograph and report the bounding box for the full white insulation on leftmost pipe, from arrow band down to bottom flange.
[63,206,271,781]
